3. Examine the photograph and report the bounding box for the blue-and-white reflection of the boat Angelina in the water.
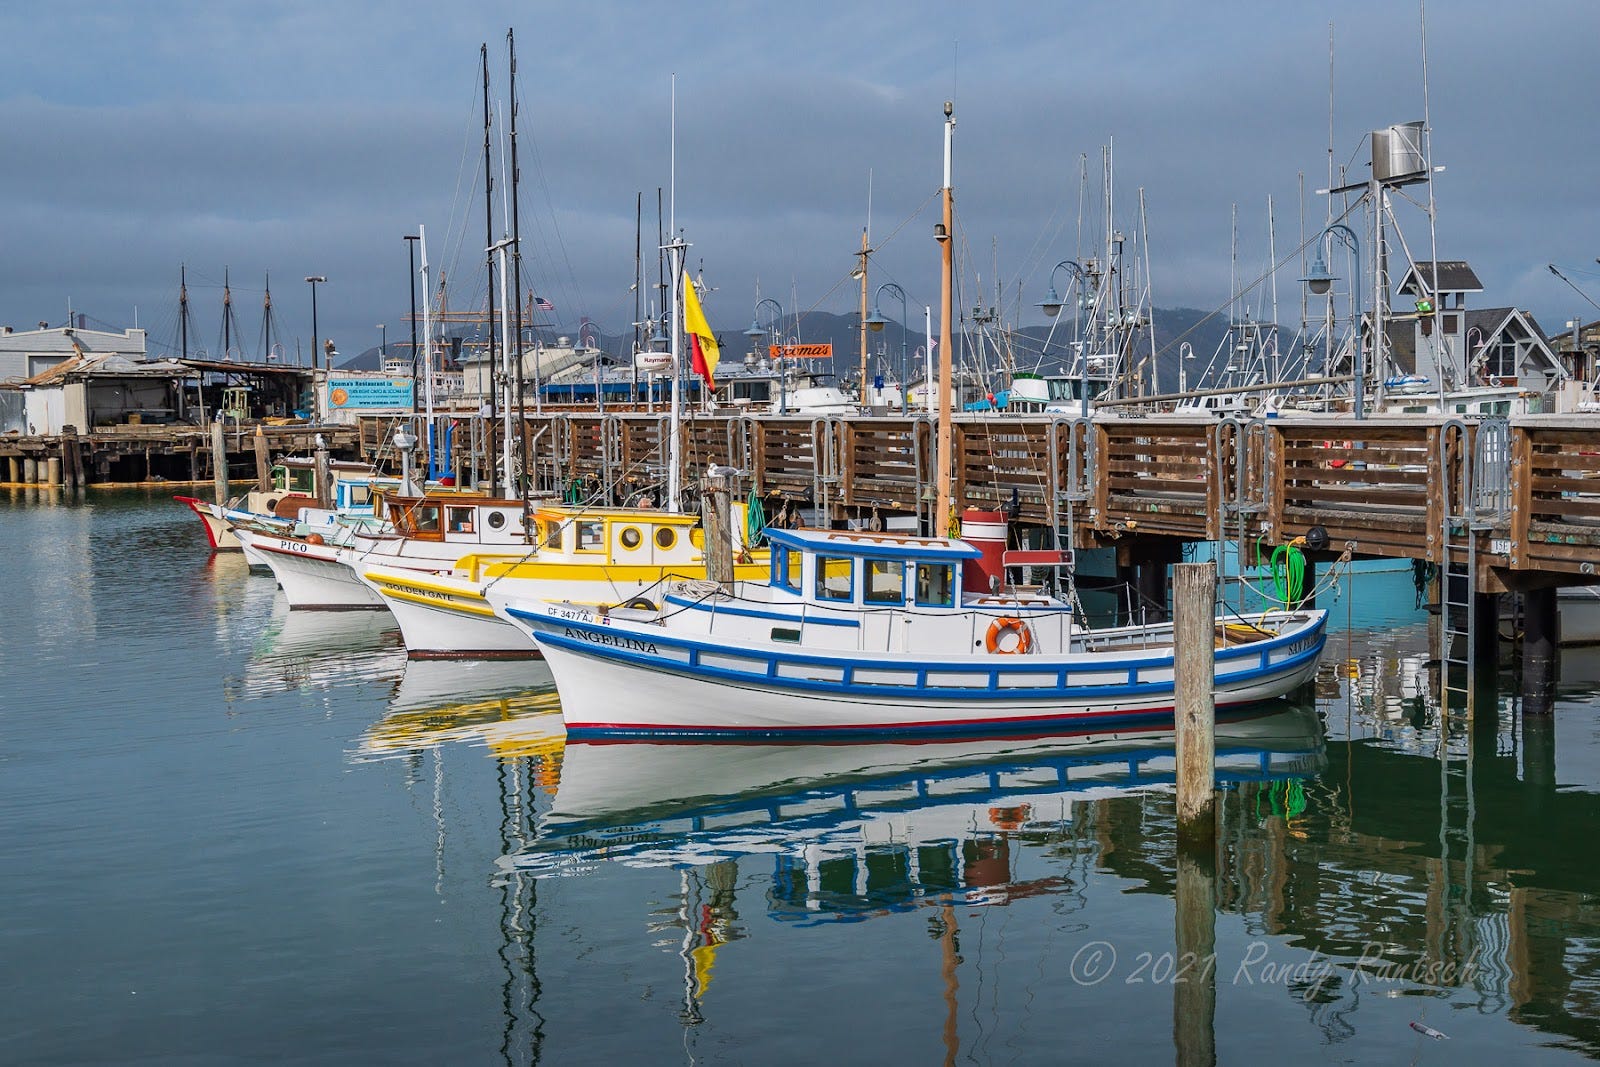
[502,705,1326,895]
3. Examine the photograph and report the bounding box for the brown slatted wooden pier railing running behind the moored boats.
[360,408,1600,593]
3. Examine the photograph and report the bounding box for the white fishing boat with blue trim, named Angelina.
[488,530,1328,737]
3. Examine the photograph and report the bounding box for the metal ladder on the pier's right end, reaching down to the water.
[1437,418,1510,720]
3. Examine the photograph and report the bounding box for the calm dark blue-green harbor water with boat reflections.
[0,491,1600,1064]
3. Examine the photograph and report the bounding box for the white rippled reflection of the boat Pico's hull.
[230,595,405,697]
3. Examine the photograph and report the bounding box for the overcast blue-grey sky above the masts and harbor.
[0,0,1600,363]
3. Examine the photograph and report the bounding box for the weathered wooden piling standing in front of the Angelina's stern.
[1173,563,1216,851]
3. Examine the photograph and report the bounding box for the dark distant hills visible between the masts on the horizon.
[339,307,1227,390]
